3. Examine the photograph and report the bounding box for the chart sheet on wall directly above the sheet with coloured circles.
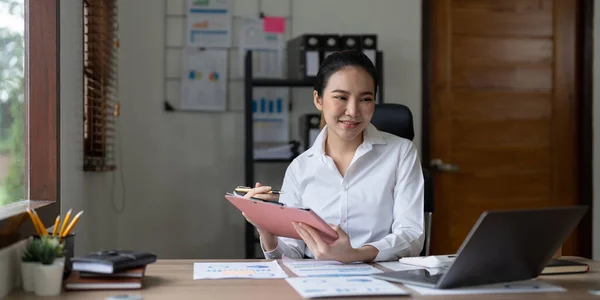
[186,0,232,48]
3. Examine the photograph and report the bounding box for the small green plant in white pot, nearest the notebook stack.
[33,236,65,296]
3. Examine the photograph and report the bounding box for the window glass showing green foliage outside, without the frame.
[0,0,25,207]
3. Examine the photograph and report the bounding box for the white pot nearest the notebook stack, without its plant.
[33,261,65,296]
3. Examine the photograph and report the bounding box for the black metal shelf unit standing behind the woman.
[244,50,384,259]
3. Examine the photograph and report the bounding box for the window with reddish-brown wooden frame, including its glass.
[0,0,59,248]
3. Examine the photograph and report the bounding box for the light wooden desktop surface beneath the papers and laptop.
[6,257,600,300]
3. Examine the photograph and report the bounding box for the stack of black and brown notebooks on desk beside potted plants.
[64,250,156,290]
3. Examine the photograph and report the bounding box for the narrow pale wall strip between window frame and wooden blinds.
[60,0,118,255]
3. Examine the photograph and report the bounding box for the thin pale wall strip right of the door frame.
[592,3,600,259]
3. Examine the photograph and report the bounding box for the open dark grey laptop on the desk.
[371,206,587,289]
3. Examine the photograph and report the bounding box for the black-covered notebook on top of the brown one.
[71,250,156,274]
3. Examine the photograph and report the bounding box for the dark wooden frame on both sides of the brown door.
[421,0,600,259]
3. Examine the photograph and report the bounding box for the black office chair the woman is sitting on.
[371,103,433,255]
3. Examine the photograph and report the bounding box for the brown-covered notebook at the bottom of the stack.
[64,271,143,290]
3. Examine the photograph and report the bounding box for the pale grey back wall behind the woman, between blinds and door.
[108,0,420,258]
